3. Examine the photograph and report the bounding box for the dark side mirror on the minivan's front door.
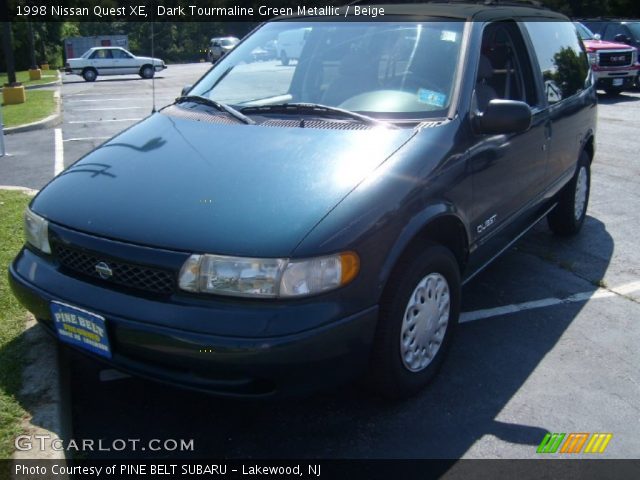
[476,100,532,135]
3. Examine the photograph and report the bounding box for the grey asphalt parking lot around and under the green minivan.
[3,64,640,458]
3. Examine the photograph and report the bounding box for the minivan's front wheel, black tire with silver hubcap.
[366,243,460,399]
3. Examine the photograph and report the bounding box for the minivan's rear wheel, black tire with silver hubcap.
[547,151,591,237]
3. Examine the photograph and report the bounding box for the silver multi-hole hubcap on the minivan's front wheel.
[400,273,450,372]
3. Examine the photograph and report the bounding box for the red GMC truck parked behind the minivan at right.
[576,22,640,95]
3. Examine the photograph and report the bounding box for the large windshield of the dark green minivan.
[189,19,465,119]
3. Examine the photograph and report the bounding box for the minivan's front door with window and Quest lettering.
[468,22,550,268]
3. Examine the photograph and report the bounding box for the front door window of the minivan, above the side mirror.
[475,22,539,111]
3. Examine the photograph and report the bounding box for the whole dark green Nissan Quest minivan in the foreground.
[10,4,597,398]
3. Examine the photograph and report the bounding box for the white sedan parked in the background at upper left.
[65,47,167,82]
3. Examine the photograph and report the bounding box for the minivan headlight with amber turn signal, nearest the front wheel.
[178,252,360,298]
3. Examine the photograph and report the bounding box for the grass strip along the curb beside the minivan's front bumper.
[0,190,30,458]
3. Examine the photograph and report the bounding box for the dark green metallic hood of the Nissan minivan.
[32,113,413,257]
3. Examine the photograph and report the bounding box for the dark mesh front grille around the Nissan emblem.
[51,242,175,295]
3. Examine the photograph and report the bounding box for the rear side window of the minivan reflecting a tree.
[526,21,589,104]
